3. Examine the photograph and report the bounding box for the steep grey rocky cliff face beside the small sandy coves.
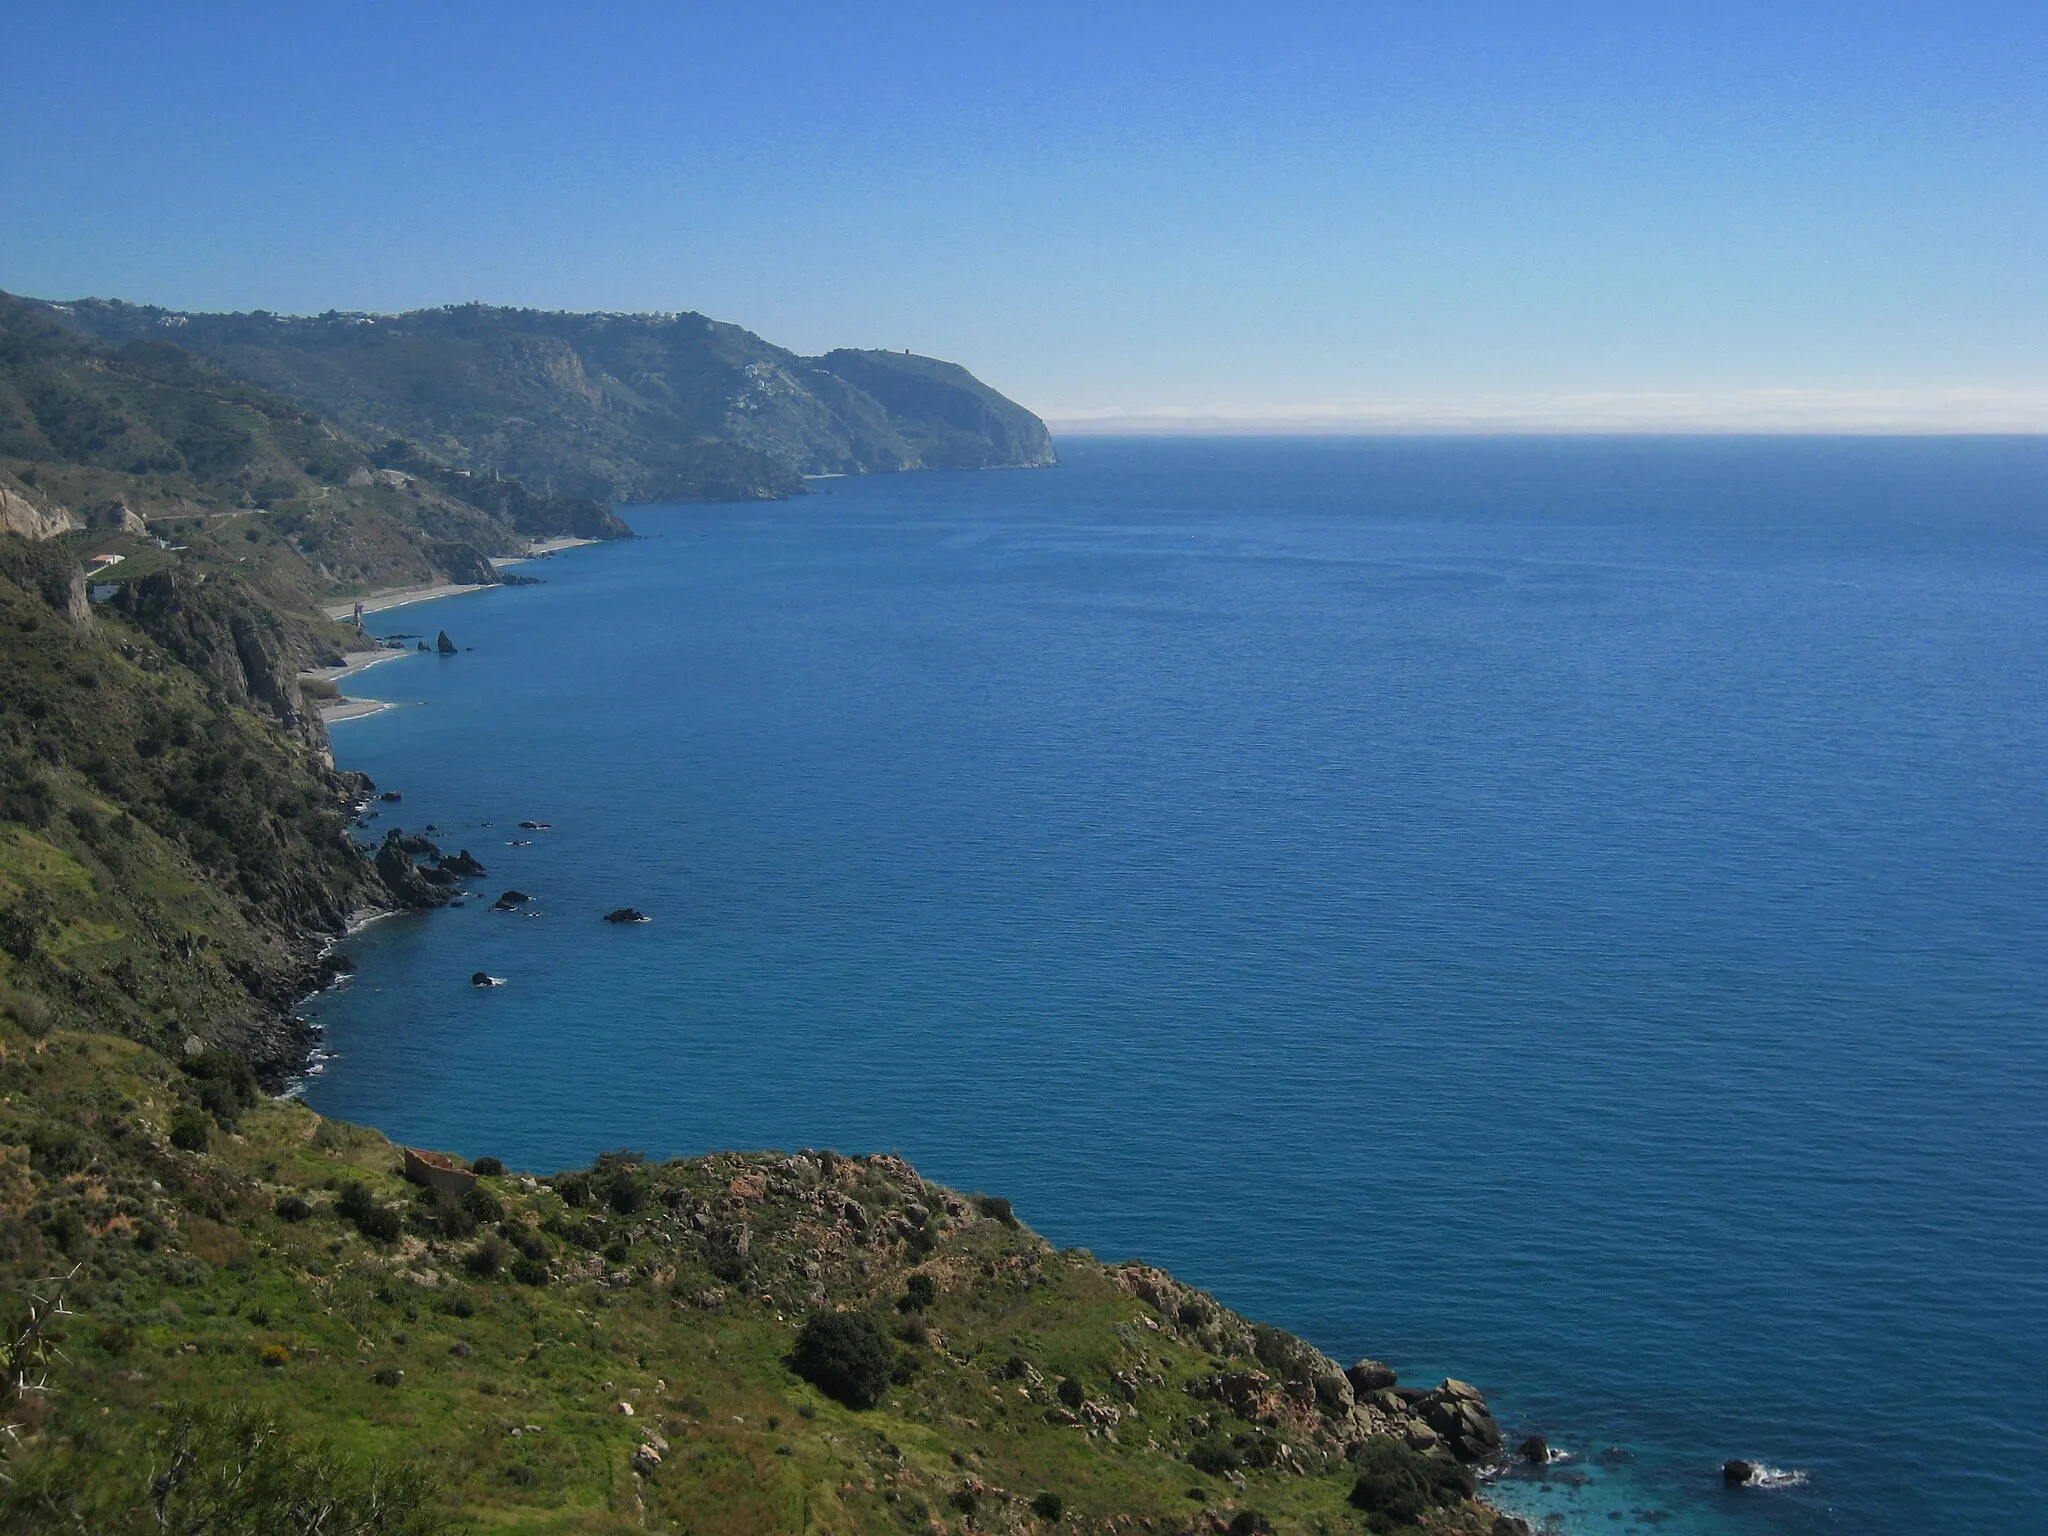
[115,567,328,743]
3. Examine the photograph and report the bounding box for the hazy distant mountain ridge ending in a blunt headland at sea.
[37,299,1057,502]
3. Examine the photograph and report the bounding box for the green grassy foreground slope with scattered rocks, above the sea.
[0,1028,1491,1532]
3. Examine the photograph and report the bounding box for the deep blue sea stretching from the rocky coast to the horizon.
[307,440,2048,1536]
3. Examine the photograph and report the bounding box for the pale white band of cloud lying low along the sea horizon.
[1042,389,2048,436]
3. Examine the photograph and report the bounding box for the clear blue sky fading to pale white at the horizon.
[0,0,2048,430]
